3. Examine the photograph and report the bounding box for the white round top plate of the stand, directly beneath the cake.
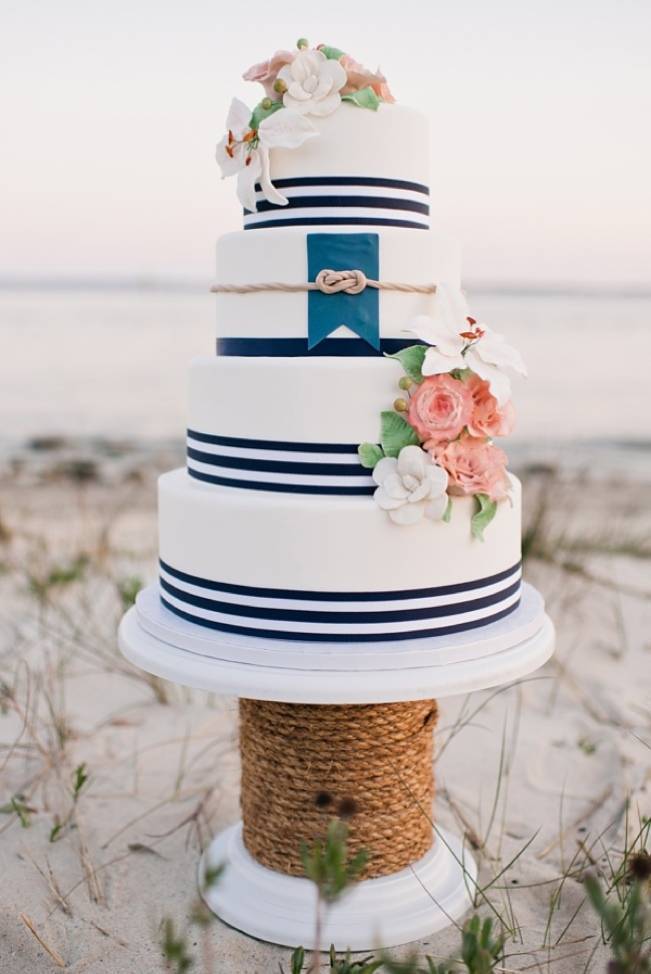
[119,585,554,704]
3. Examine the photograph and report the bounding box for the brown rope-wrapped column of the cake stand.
[240,700,437,878]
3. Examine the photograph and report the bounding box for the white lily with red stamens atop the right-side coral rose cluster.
[409,284,527,405]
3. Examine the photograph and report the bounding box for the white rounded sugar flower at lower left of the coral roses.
[373,446,448,524]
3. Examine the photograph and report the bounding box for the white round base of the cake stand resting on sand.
[199,824,477,950]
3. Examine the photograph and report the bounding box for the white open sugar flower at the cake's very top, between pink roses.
[278,49,348,115]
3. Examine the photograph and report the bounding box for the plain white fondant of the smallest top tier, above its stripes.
[271,103,429,187]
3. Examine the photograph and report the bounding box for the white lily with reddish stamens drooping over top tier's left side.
[217,98,318,212]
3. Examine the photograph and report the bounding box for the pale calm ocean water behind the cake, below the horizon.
[0,287,651,477]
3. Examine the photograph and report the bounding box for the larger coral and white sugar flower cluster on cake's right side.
[359,285,526,538]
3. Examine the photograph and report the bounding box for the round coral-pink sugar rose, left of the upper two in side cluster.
[407,374,472,443]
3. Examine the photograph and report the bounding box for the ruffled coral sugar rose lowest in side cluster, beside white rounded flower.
[424,436,509,501]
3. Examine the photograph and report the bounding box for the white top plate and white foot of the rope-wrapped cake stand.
[119,584,554,950]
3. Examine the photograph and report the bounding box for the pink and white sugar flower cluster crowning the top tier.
[217,38,395,212]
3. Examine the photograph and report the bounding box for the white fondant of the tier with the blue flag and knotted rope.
[216,228,460,341]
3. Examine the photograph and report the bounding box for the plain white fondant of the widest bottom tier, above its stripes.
[159,470,520,592]
